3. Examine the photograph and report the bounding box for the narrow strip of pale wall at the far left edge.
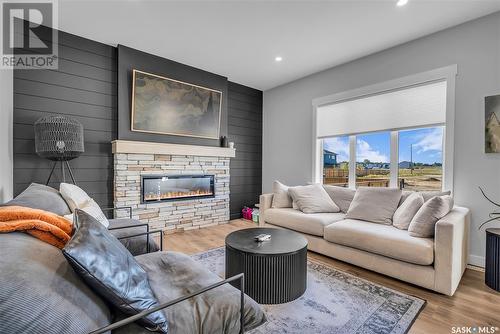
[0,70,14,203]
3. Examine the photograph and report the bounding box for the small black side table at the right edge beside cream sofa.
[484,228,500,292]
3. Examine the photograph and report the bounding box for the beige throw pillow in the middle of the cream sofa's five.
[346,187,401,225]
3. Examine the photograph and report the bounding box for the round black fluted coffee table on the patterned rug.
[226,228,307,304]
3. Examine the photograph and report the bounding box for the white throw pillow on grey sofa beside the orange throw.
[59,183,109,227]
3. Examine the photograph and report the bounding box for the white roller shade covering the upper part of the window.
[316,81,446,138]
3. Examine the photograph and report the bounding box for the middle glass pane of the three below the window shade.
[356,132,391,187]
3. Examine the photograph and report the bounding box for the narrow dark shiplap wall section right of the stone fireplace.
[228,82,262,219]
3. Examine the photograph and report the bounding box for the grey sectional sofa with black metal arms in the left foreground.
[0,184,266,334]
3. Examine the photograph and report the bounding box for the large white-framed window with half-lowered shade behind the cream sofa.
[312,65,457,191]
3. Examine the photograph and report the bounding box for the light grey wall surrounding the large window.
[262,12,500,265]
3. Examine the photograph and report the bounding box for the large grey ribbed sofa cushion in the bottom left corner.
[0,232,112,334]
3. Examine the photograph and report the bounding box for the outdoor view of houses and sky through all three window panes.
[323,126,443,190]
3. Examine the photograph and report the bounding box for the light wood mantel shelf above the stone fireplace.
[111,140,236,158]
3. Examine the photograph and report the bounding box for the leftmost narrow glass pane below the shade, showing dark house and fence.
[323,136,349,187]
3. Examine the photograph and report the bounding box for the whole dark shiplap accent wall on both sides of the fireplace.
[10,28,262,218]
